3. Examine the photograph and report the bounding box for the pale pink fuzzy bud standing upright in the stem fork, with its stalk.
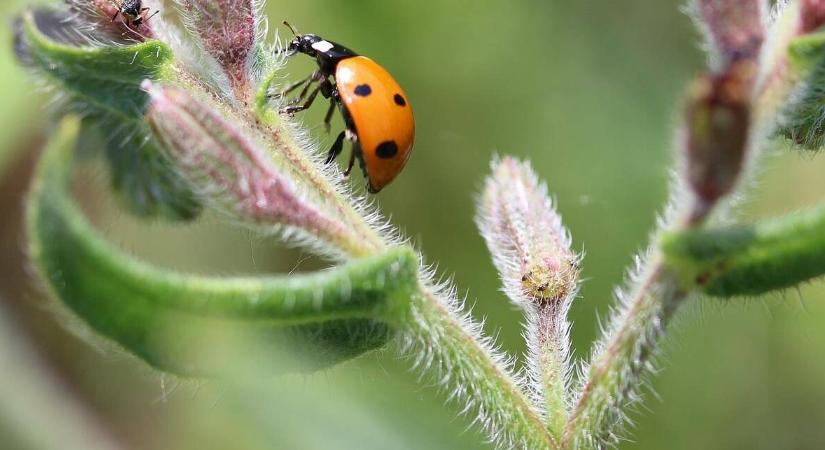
[476,157,579,432]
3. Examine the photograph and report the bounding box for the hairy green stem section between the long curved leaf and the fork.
[402,285,558,449]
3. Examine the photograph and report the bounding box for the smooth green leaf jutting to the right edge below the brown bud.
[662,207,825,297]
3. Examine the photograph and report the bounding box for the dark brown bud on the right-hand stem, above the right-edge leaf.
[686,61,755,215]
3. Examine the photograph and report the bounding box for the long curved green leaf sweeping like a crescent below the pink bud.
[27,118,417,376]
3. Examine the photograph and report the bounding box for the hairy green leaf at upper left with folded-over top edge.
[17,10,202,220]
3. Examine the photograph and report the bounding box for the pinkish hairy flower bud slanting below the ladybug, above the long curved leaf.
[143,81,363,254]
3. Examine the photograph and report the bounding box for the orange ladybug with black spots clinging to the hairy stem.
[280,22,415,194]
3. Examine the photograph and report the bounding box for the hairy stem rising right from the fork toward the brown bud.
[560,195,700,449]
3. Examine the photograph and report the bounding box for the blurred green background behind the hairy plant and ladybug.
[0,0,825,449]
